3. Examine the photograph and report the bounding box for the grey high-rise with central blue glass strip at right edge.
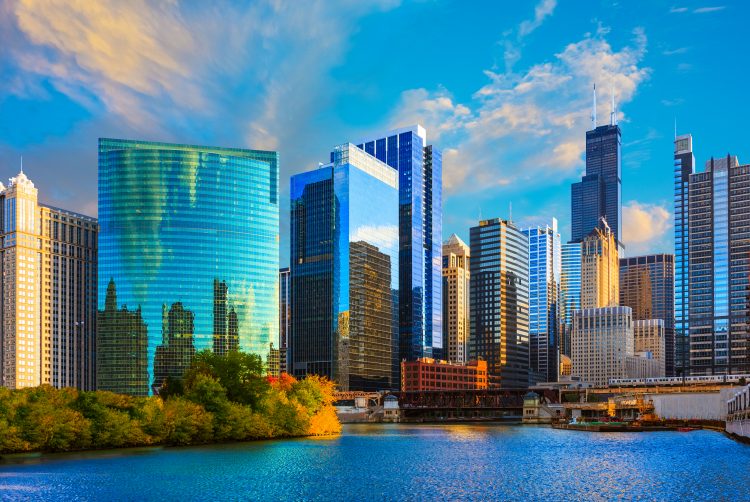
[683,155,750,375]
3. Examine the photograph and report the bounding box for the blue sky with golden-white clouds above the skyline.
[0,0,750,264]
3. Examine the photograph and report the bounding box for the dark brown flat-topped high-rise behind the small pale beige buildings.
[620,254,675,376]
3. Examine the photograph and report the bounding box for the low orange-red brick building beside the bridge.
[401,357,487,392]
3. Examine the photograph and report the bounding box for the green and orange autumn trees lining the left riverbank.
[0,350,341,453]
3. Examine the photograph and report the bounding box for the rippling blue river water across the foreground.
[0,424,750,501]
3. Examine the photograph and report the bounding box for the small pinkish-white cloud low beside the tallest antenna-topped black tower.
[622,201,672,256]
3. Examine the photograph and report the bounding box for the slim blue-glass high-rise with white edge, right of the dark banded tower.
[522,218,562,384]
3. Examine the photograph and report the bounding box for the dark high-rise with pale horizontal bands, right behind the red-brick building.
[469,218,529,388]
